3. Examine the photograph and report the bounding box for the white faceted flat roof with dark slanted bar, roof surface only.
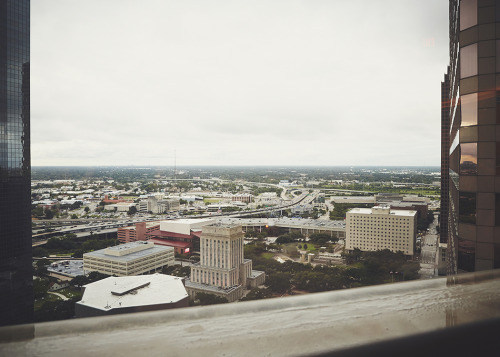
[77,274,188,311]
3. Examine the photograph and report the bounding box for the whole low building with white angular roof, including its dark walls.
[75,274,189,317]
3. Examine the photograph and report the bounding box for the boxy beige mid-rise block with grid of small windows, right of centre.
[345,207,417,255]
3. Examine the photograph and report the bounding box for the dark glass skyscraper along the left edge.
[0,0,33,325]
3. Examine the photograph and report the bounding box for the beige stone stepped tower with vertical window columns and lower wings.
[186,224,265,302]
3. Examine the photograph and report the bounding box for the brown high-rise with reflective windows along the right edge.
[441,0,500,274]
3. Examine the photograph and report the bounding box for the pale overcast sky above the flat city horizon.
[31,0,448,166]
